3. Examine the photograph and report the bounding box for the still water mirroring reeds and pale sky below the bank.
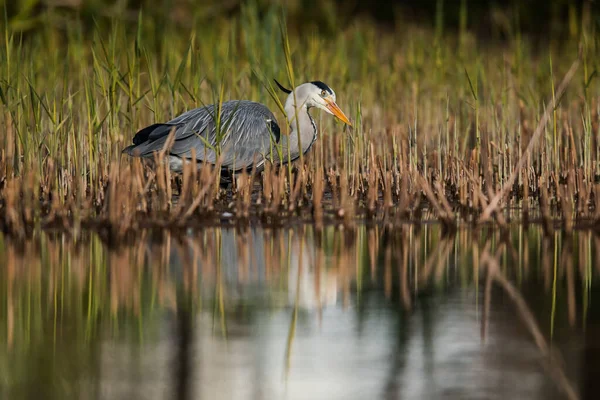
[0,224,600,400]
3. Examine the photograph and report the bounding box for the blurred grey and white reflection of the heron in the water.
[170,228,342,310]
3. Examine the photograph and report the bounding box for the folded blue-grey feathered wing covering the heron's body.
[124,100,279,170]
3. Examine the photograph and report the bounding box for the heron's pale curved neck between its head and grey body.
[282,102,317,160]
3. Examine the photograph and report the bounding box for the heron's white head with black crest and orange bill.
[275,81,352,126]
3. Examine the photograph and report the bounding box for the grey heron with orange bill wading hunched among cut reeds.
[123,80,352,177]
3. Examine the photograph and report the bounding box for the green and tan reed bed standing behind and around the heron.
[0,2,600,239]
